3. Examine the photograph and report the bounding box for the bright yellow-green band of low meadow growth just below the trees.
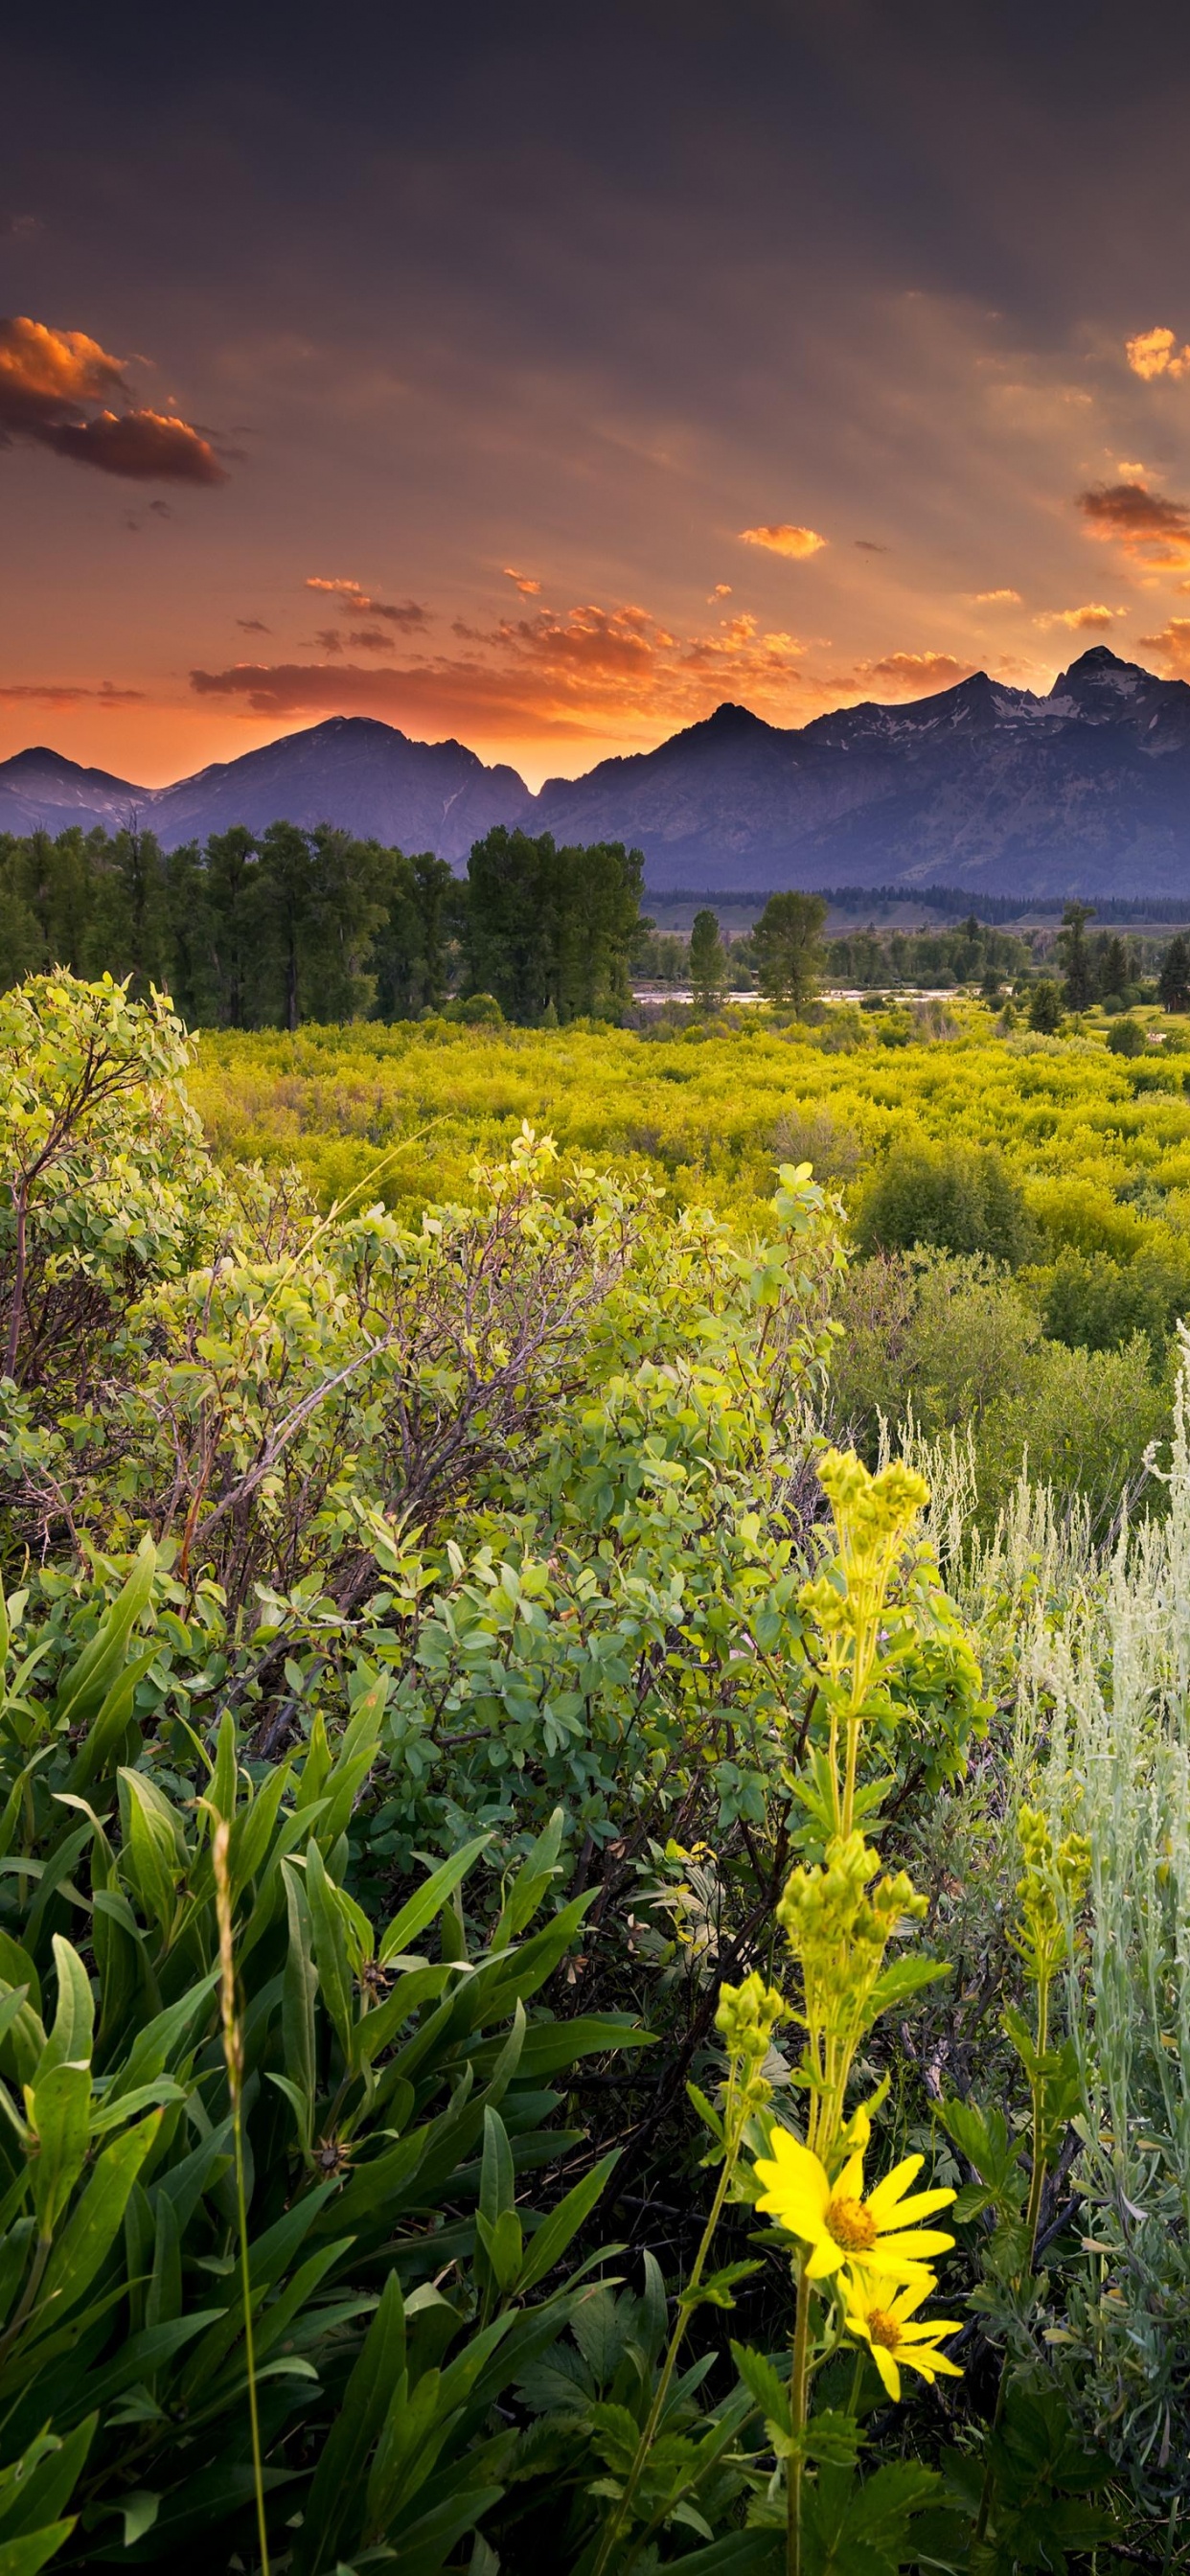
[191,1002,1190,1226]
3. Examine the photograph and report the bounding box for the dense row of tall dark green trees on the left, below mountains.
[0,821,644,1028]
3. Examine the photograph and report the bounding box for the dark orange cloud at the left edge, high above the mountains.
[0,314,227,484]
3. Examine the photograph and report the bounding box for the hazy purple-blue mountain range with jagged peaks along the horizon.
[0,644,1190,896]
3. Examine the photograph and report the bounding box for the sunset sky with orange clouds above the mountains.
[0,0,1190,786]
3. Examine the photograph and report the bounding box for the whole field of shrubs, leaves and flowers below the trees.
[0,974,1190,2576]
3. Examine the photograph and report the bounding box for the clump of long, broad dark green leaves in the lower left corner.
[0,1551,652,2576]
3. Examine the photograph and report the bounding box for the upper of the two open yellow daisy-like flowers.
[757,2128,955,2283]
